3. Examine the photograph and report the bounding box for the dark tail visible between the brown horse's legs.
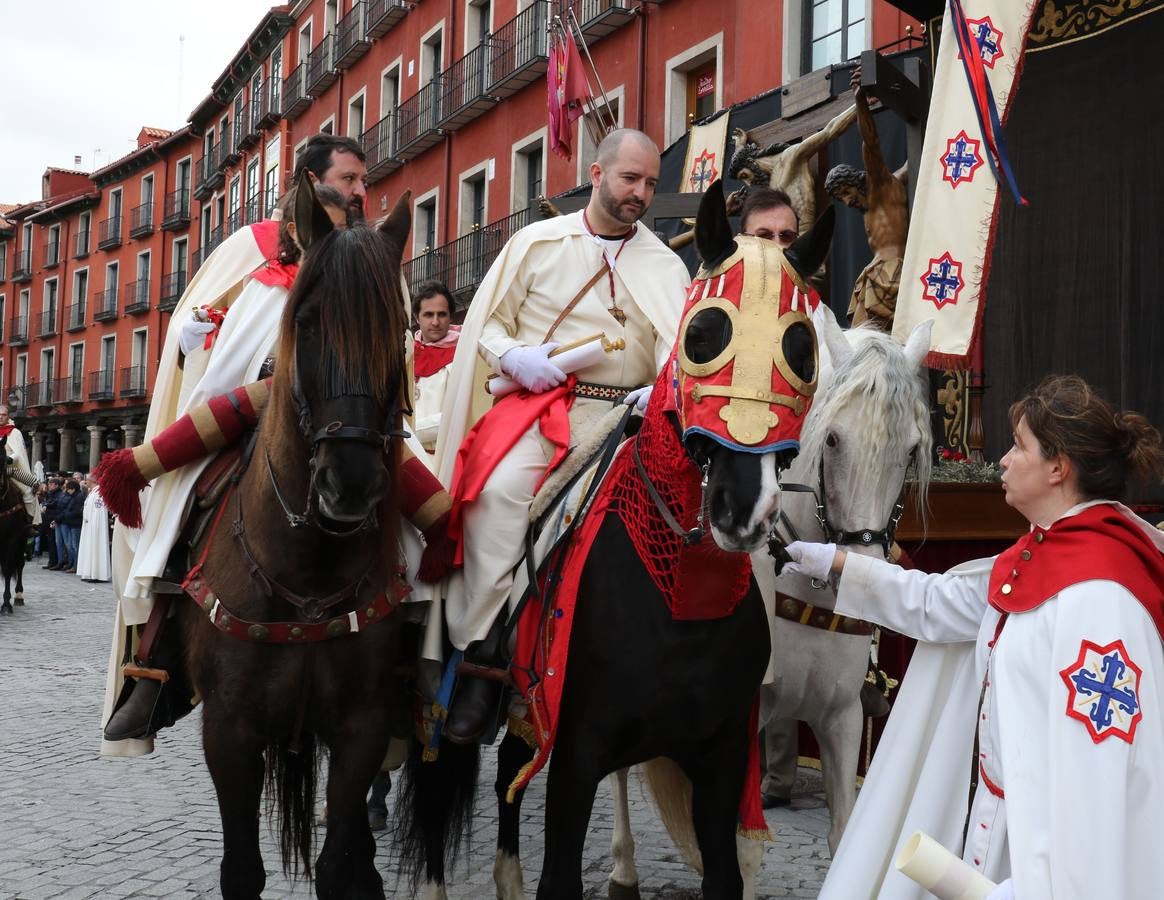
[264,735,319,878]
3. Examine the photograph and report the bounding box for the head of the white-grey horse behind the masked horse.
[796,312,932,555]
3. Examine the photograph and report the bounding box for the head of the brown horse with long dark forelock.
[276,172,410,531]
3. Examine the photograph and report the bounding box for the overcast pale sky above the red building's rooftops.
[0,0,277,203]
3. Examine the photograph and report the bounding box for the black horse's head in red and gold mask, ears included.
[675,182,832,552]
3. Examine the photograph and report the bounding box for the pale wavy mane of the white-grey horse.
[797,326,932,509]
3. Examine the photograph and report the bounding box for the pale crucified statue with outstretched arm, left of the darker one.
[728,100,857,234]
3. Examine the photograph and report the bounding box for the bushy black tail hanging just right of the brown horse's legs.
[395,740,481,893]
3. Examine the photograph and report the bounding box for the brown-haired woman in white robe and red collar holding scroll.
[785,376,1164,900]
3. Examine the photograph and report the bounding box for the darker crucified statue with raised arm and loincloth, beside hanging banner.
[824,68,909,331]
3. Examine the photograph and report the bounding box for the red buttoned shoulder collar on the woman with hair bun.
[987,503,1164,639]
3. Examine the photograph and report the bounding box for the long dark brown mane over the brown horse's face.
[277,226,407,403]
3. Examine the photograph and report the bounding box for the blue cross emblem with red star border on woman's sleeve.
[1059,640,1144,744]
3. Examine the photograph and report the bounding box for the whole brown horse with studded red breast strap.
[179,180,410,900]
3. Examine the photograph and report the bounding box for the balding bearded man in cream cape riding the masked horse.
[437,128,690,743]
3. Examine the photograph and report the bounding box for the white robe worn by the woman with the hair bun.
[821,504,1164,900]
